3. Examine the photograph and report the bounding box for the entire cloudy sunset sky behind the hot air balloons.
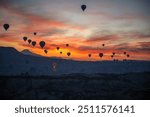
[0,0,150,61]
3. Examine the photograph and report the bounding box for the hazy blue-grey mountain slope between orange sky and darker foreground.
[0,47,150,76]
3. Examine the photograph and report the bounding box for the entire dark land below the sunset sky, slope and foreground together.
[0,47,150,99]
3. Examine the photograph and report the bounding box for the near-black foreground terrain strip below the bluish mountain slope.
[0,72,150,100]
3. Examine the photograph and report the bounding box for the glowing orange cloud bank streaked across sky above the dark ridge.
[0,3,150,60]
